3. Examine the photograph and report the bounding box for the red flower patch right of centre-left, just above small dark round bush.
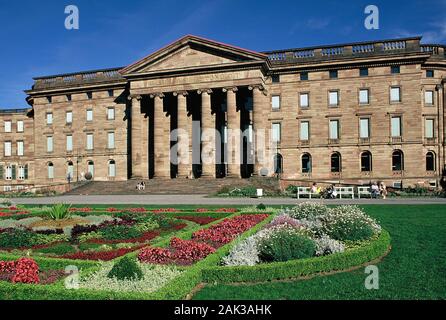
[138,238,215,265]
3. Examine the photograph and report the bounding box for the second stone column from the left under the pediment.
[151,93,171,179]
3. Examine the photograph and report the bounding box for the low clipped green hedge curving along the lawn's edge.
[202,230,391,283]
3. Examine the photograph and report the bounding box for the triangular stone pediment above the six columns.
[121,36,266,76]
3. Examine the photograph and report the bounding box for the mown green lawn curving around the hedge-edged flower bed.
[194,205,446,300]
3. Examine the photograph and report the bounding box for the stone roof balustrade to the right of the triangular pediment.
[265,38,445,63]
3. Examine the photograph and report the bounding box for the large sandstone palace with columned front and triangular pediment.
[0,35,446,191]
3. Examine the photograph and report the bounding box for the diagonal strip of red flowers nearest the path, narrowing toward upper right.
[192,214,268,247]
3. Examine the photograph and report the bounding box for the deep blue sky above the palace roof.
[0,0,446,108]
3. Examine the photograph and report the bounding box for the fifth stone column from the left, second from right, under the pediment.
[223,87,242,178]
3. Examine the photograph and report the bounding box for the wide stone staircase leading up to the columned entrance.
[66,178,279,195]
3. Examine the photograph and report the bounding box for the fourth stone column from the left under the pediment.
[198,89,217,178]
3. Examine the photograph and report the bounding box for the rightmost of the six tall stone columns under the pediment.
[249,85,269,176]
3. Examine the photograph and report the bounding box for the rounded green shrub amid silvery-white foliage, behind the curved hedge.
[258,228,316,262]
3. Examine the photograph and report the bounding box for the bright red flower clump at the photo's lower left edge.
[0,258,39,283]
